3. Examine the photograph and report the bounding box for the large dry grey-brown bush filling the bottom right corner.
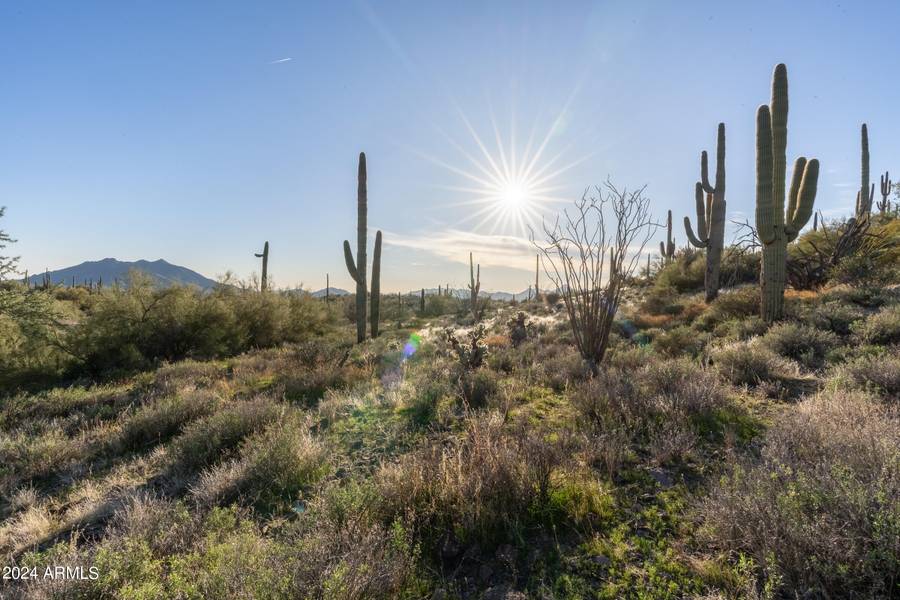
[701,392,900,598]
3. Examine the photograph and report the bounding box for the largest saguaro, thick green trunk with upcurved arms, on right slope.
[756,64,819,323]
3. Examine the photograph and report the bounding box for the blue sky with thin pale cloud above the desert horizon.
[0,0,900,291]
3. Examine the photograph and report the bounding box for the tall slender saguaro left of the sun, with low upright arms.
[344,152,381,343]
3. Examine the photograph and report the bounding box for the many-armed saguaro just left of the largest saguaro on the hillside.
[684,123,725,302]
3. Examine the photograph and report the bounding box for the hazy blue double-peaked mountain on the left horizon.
[28,258,216,290]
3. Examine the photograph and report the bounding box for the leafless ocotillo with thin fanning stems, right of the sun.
[531,179,659,371]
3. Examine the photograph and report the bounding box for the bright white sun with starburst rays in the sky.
[420,104,588,236]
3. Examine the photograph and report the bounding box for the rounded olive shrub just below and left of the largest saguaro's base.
[710,340,796,386]
